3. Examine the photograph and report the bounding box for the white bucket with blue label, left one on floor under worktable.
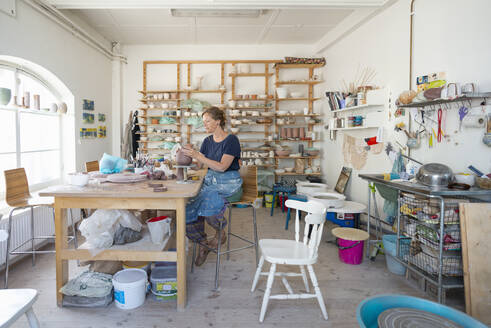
[113,269,148,310]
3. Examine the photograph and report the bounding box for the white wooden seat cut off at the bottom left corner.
[0,289,40,328]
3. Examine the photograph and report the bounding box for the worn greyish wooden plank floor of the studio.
[1,208,460,328]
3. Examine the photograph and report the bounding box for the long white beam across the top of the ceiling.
[45,0,389,9]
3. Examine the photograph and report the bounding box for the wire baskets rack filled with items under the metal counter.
[399,193,463,277]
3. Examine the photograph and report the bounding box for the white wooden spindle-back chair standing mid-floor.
[251,199,327,322]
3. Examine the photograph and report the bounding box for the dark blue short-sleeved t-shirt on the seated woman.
[200,134,240,171]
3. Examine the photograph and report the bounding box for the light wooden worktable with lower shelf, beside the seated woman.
[39,180,202,310]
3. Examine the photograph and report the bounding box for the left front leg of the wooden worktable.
[55,205,68,306]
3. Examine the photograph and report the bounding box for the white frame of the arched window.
[0,62,64,198]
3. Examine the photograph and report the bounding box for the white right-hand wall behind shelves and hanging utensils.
[323,0,491,203]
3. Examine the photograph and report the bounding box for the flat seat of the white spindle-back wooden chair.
[259,239,317,265]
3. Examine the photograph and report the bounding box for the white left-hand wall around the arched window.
[0,1,111,170]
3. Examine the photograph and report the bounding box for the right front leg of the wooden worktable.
[176,199,187,311]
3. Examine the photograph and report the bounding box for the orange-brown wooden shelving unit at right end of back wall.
[275,63,324,177]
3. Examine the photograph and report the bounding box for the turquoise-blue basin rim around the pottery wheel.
[356,295,488,328]
